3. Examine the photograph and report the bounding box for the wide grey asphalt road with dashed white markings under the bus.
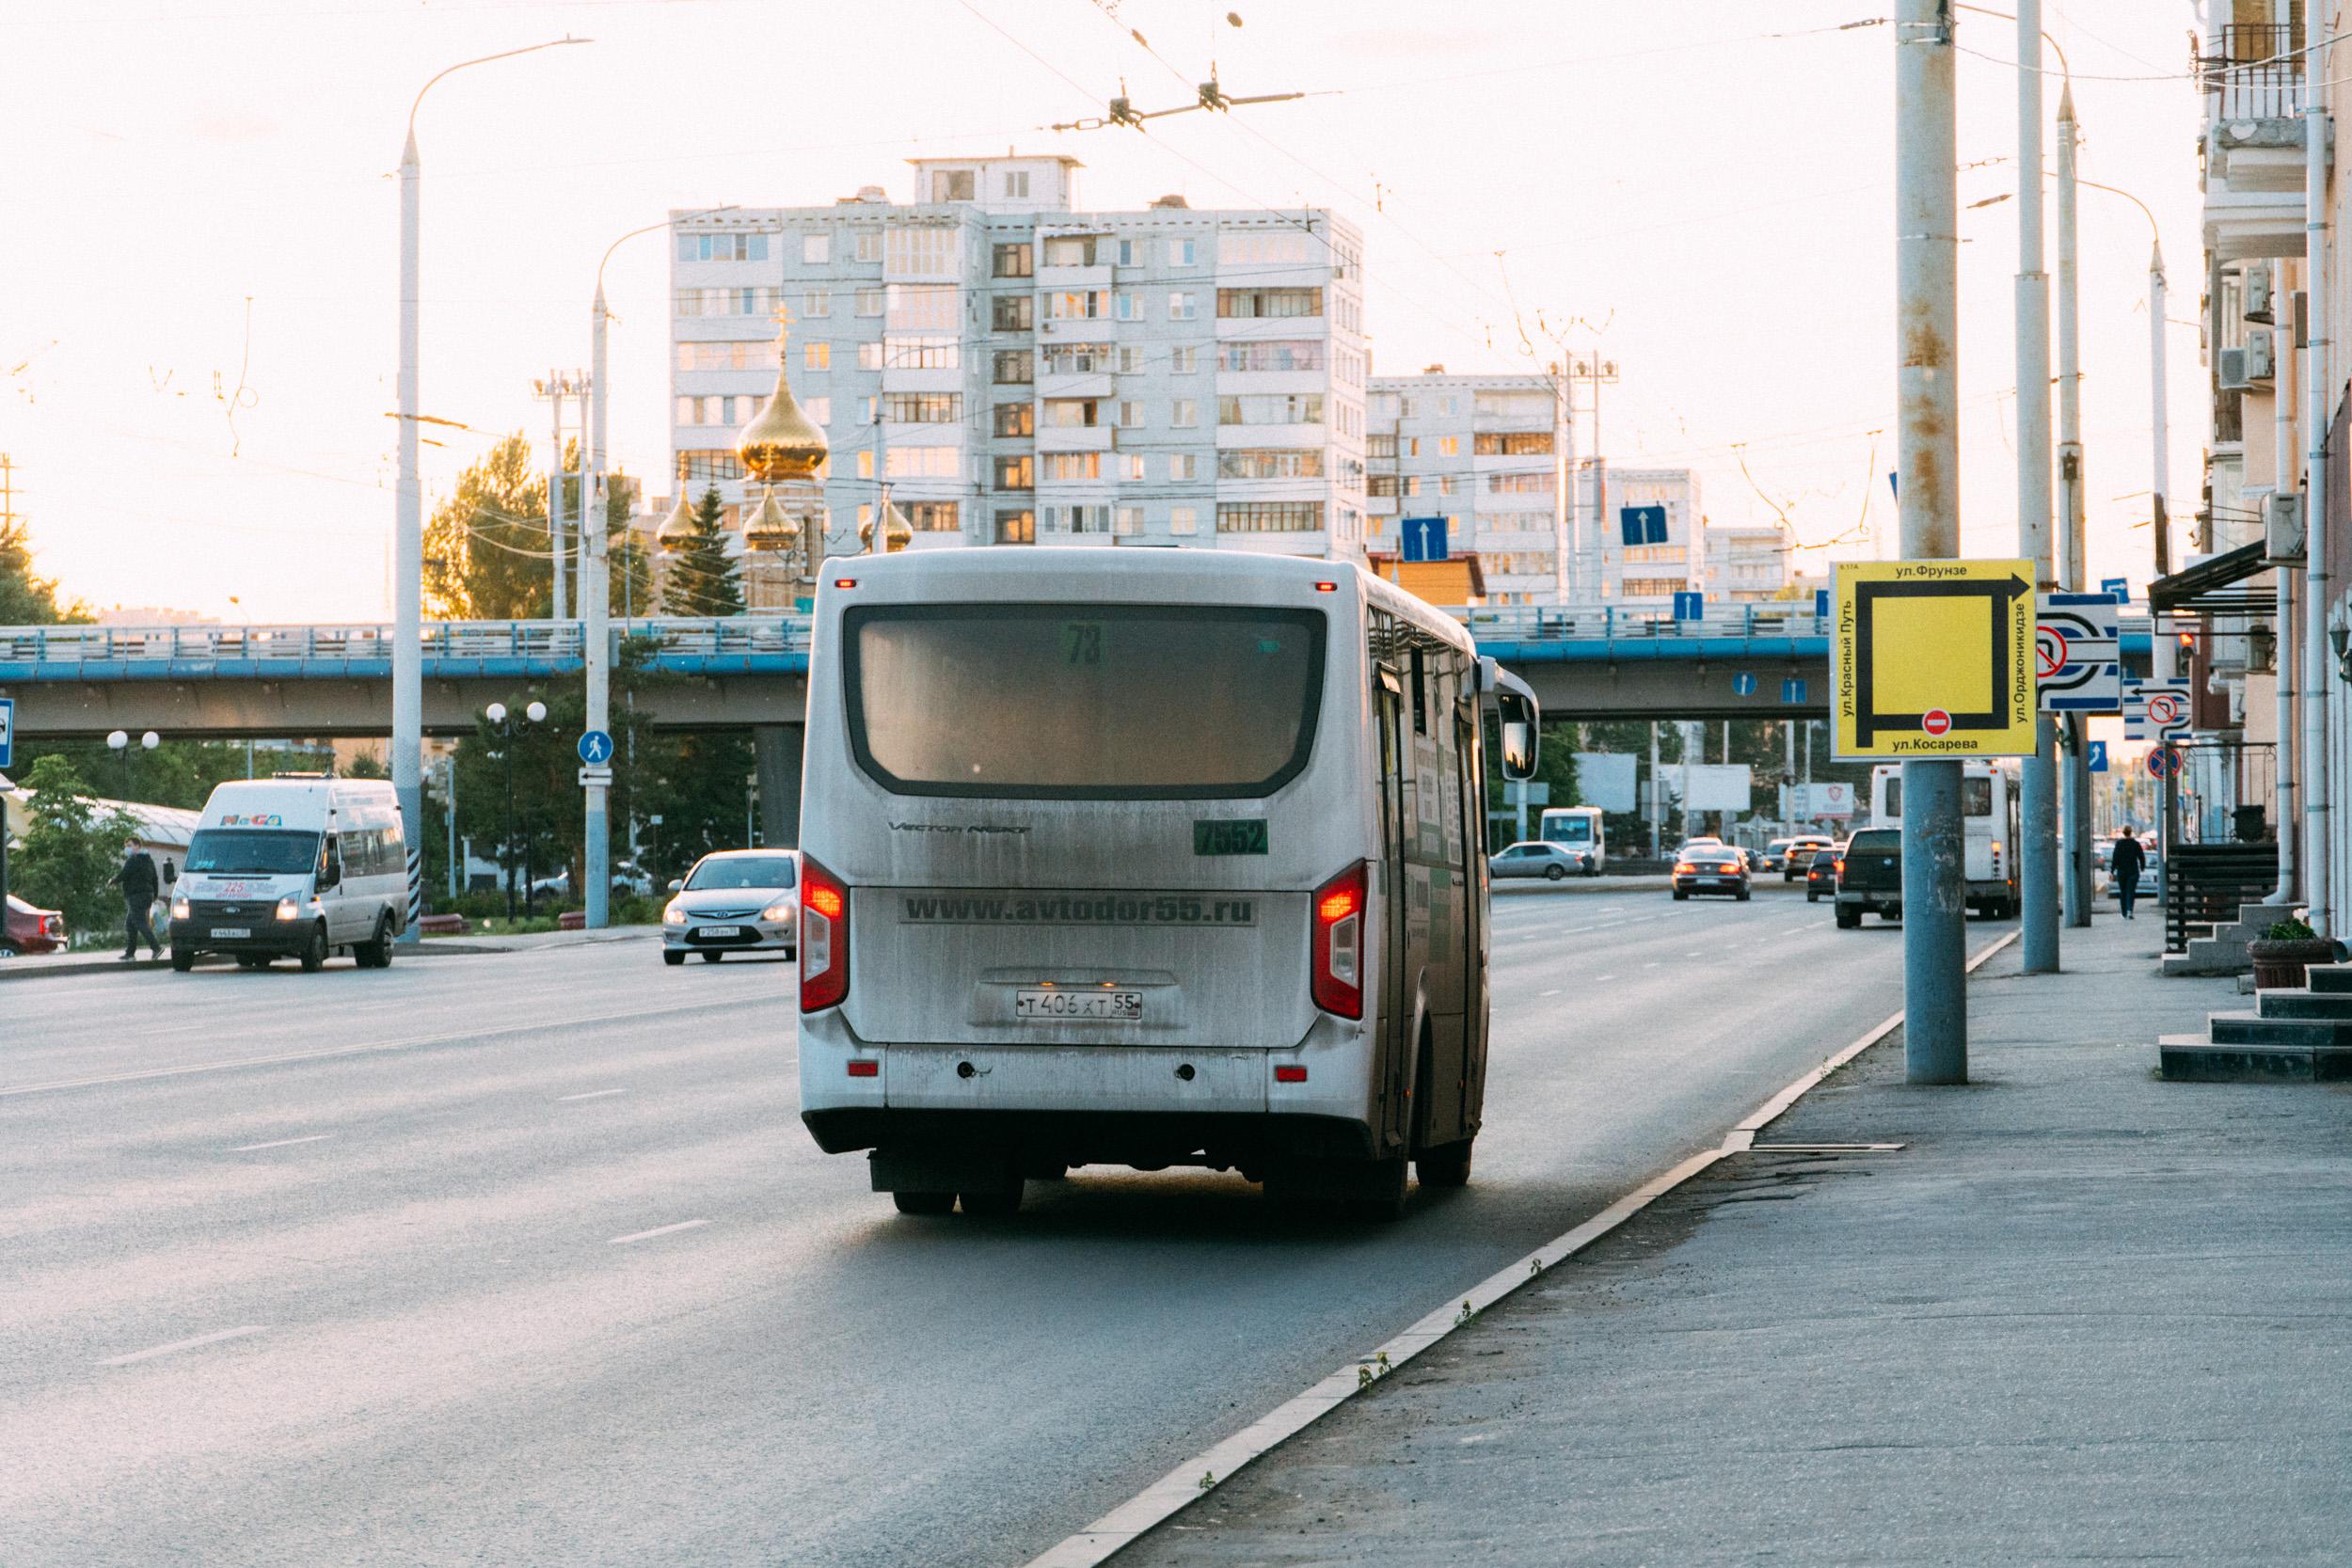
[0,881,1966,1568]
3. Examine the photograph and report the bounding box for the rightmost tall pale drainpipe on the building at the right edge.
[2280,5,2336,936]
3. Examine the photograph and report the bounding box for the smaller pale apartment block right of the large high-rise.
[1364,364,1571,604]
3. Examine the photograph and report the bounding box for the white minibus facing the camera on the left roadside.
[172,773,409,974]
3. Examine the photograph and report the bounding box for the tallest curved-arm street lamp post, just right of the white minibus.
[393,38,588,942]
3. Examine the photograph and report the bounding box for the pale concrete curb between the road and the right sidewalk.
[1025,931,2018,1568]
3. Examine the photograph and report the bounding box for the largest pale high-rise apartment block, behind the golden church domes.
[671,155,1367,560]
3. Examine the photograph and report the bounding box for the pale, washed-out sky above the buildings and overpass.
[0,0,2206,621]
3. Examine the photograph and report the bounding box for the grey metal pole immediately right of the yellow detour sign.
[2018,0,2058,975]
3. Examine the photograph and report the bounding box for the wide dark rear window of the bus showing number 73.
[842,604,1325,800]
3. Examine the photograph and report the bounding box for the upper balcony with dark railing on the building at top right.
[2201,24,2305,261]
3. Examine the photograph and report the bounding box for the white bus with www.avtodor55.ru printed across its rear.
[800,547,1536,1215]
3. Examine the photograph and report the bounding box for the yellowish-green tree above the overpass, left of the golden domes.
[426,430,555,621]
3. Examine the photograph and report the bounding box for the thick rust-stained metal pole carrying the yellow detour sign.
[1896,0,1969,1084]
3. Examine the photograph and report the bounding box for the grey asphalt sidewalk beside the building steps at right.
[1113,917,2352,1568]
